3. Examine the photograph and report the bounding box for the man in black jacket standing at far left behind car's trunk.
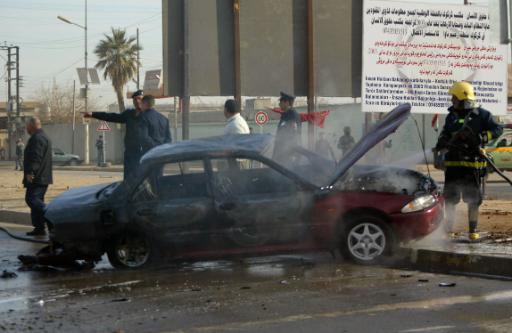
[23,117,53,236]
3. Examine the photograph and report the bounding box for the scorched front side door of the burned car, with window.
[210,158,313,247]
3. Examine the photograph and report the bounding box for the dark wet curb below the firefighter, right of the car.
[409,249,512,279]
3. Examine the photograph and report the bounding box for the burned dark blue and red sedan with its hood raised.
[45,105,443,268]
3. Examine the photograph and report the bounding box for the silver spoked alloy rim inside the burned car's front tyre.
[347,223,386,261]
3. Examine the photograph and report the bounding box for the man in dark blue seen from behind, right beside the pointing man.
[139,95,172,156]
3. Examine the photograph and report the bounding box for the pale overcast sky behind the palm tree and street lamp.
[0,0,488,108]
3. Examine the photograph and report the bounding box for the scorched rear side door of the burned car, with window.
[131,160,214,249]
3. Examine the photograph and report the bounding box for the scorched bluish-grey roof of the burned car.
[141,134,272,164]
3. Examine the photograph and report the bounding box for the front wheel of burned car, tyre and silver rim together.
[340,215,395,265]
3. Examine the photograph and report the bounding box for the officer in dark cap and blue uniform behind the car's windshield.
[273,92,301,163]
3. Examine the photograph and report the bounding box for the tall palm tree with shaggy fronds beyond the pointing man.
[94,28,142,112]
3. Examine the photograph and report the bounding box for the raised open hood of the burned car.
[327,103,411,186]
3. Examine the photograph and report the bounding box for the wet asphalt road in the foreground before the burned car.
[0,225,512,333]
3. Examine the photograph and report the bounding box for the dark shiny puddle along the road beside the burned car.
[0,254,352,314]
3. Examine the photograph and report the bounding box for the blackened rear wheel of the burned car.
[107,232,155,269]
